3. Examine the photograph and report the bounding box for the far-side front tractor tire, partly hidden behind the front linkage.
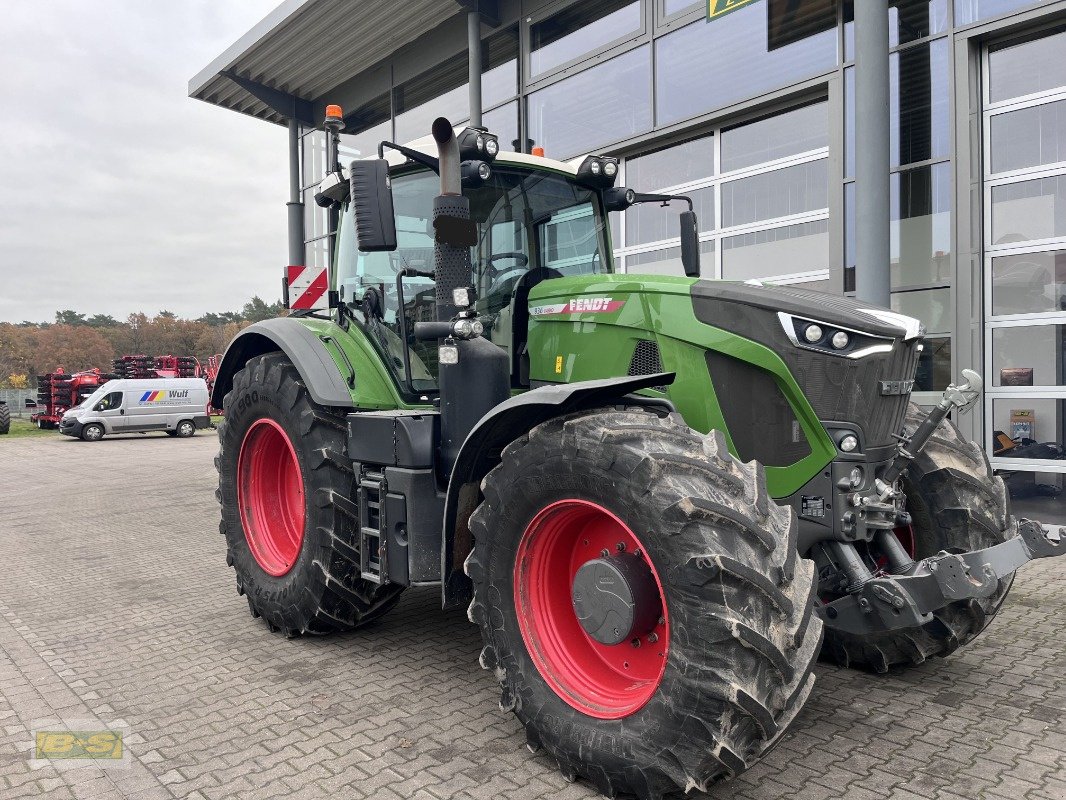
[824,403,1018,672]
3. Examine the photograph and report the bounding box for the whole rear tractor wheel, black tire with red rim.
[215,352,401,636]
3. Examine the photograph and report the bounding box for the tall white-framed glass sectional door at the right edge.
[982,29,1066,524]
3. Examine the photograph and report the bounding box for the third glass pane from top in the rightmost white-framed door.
[991,175,1066,244]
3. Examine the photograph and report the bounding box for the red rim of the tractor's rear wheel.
[237,419,305,577]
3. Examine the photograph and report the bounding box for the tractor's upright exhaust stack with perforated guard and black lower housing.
[428,116,511,476]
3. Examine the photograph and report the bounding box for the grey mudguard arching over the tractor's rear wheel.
[211,317,355,409]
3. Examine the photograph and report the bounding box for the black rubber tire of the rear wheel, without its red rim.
[214,352,402,637]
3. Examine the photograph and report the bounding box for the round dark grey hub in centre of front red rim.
[571,554,662,644]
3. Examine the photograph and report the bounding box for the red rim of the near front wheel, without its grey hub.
[515,499,669,719]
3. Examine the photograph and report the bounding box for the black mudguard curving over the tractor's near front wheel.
[440,372,674,608]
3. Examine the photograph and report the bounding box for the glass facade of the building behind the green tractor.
[294,0,1066,523]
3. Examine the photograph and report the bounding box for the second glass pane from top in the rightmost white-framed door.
[988,100,1066,172]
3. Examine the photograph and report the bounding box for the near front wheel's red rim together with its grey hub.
[514,499,669,719]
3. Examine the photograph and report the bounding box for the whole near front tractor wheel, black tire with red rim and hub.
[466,409,822,798]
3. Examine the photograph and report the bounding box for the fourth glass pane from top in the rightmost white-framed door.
[992,250,1066,315]
